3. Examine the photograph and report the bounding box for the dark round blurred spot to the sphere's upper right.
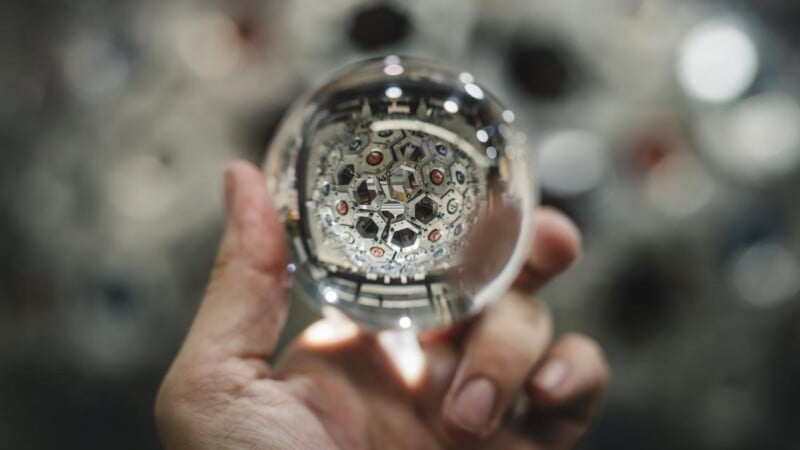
[506,38,574,101]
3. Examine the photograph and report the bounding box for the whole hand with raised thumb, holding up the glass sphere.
[155,162,608,450]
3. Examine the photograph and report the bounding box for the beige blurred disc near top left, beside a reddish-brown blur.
[177,12,244,78]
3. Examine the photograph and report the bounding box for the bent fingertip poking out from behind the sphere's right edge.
[514,207,581,293]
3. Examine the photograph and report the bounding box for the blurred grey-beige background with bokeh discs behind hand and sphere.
[0,0,800,450]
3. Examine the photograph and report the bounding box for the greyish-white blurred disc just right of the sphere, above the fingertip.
[536,130,609,197]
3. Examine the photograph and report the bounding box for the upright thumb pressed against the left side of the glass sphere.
[179,161,288,368]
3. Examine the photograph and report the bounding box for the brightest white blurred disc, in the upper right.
[677,20,759,103]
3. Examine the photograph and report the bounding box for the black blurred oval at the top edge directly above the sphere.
[350,4,411,50]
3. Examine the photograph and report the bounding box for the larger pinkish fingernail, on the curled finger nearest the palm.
[449,378,497,434]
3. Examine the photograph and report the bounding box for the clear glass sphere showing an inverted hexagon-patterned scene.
[266,56,536,332]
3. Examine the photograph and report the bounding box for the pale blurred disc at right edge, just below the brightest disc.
[730,93,800,169]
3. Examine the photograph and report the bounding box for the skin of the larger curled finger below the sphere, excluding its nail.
[442,290,552,442]
